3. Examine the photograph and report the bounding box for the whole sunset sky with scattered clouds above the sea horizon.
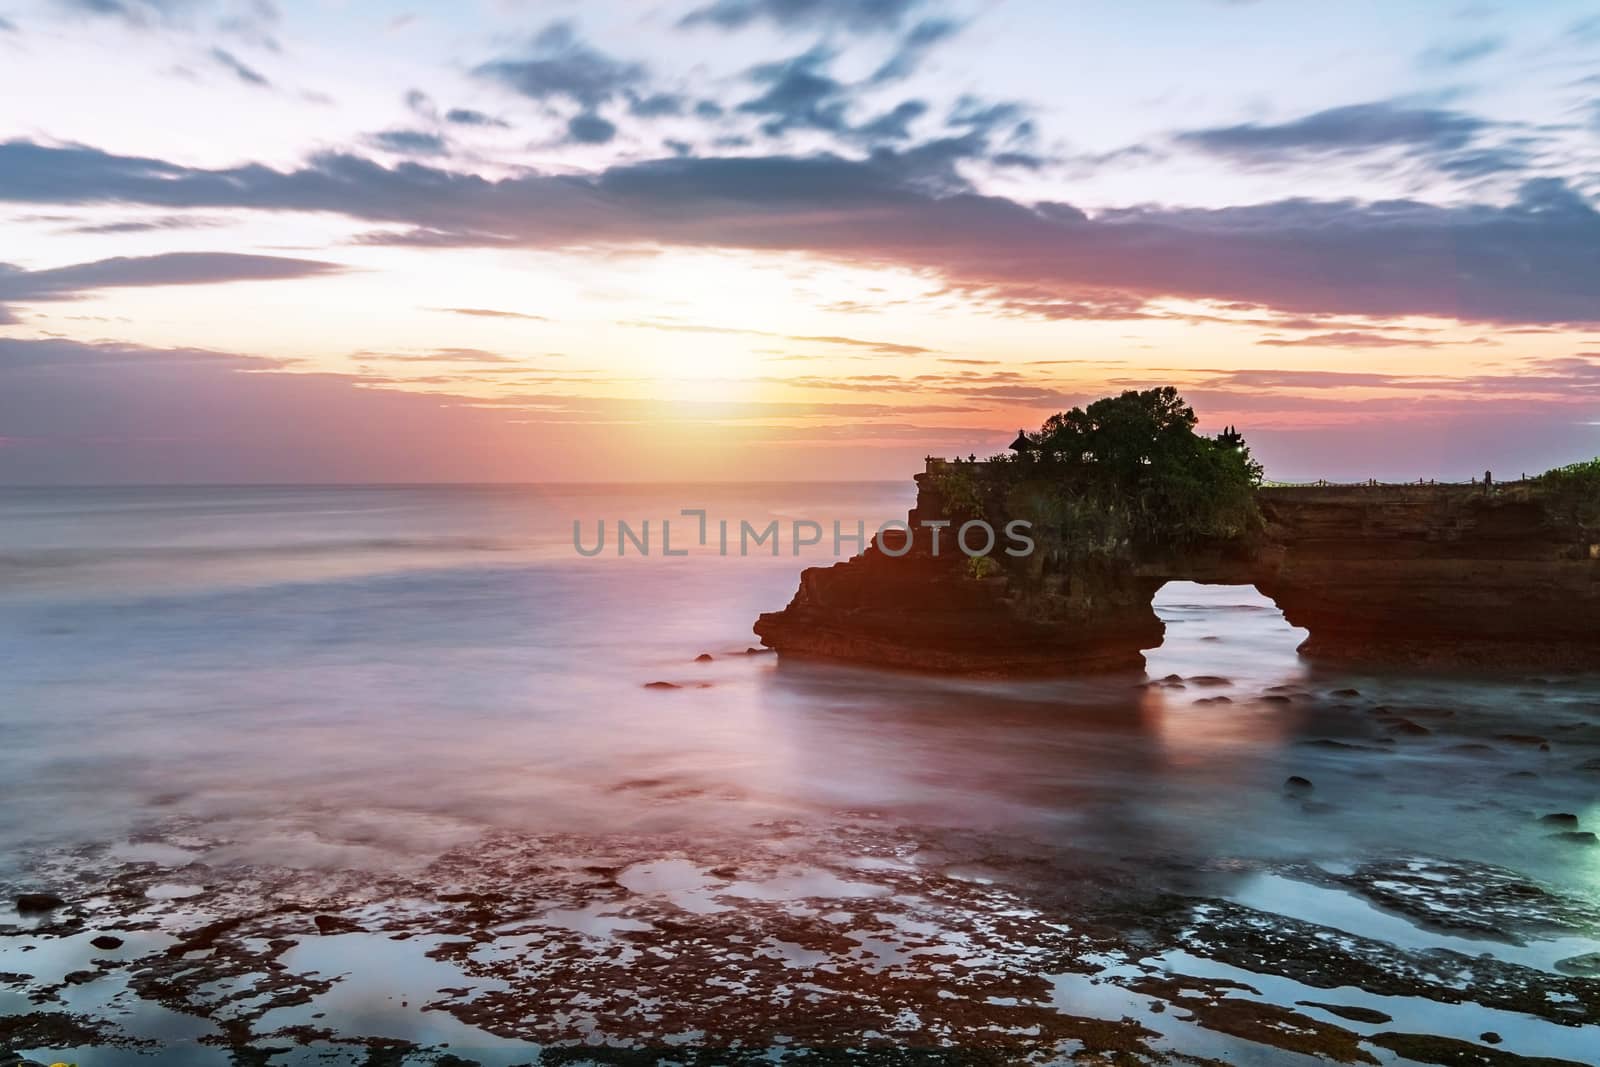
[0,0,1600,485]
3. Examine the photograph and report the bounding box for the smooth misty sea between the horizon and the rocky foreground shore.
[0,483,1600,891]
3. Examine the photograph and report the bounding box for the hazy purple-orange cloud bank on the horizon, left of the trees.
[0,338,973,485]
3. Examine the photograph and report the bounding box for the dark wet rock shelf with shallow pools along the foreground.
[0,813,1600,1065]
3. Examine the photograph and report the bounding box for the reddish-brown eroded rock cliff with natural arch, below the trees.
[755,477,1600,675]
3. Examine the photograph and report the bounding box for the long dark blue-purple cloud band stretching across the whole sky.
[0,141,1600,325]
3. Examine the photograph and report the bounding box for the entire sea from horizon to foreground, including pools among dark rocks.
[0,482,1600,1064]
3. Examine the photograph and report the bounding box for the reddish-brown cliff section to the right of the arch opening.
[1254,485,1600,667]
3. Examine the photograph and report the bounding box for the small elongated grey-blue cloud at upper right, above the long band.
[1174,102,1491,162]
